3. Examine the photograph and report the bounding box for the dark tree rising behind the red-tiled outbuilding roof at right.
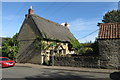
[102,10,120,23]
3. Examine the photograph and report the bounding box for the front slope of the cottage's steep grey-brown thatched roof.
[27,14,76,41]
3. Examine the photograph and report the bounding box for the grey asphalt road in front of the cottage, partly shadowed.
[2,63,117,80]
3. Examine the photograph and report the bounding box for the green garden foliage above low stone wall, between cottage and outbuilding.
[68,37,98,54]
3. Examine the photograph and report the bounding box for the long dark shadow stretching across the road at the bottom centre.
[25,72,111,80]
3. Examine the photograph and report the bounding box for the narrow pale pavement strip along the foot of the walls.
[16,63,120,74]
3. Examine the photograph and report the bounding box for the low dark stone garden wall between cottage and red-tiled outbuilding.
[50,56,100,68]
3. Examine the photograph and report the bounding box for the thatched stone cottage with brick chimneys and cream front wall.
[17,7,76,64]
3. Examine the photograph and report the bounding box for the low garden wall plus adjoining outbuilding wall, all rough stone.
[51,39,120,70]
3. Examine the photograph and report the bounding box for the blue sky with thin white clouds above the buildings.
[1,2,118,43]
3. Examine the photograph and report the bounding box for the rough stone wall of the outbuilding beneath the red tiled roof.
[98,39,120,69]
